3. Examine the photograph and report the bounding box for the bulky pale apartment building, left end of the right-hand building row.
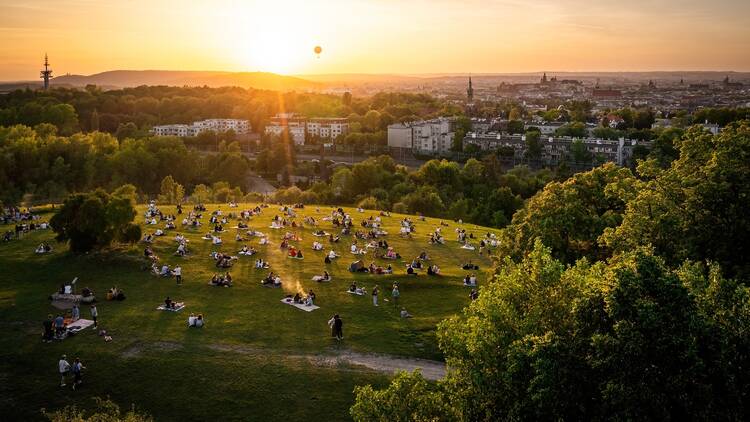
[388,117,455,155]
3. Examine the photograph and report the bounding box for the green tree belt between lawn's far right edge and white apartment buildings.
[276,155,556,227]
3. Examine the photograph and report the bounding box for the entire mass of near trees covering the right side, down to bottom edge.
[351,121,750,421]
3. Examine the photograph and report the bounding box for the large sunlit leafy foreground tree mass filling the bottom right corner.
[350,241,750,421]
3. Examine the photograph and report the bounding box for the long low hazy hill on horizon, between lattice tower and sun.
[52,70,319,91]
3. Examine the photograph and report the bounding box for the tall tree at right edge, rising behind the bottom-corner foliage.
[603,121,750,275]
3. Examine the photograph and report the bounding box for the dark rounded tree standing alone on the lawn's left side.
[50,189,140,253]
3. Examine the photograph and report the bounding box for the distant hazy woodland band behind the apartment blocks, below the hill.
[0,85,462,145]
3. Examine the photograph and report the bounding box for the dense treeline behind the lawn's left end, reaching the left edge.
[0,123,250,204]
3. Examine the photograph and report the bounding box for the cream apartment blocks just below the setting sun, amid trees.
[265,113,349,145]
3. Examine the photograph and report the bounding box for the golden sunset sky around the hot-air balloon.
[0,0,750,80]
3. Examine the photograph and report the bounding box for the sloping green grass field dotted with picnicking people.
[0,204,502,421]
